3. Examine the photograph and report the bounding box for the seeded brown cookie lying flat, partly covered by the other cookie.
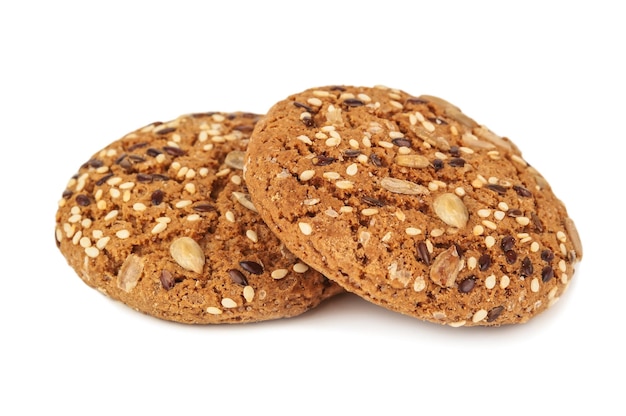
[55,113,342,324]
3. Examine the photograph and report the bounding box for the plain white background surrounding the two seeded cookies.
[0,0,626,415]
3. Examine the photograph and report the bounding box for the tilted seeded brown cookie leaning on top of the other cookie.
[244,86,582,326]
